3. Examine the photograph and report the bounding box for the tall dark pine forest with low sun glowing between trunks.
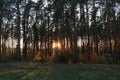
[0,0,120,63]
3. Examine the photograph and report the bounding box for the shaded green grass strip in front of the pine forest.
[0,63,120,80]
